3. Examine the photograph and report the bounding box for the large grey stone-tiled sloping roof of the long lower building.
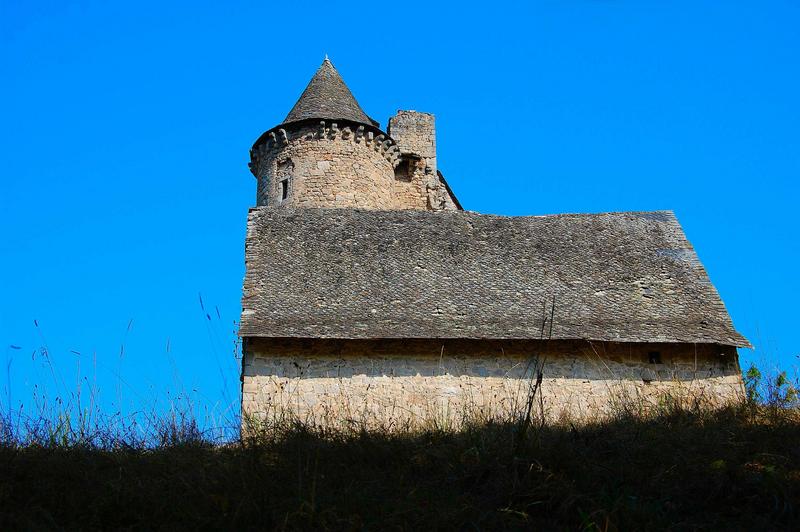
[240,207,749,346]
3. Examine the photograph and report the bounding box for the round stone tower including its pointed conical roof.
[249,57,400,209]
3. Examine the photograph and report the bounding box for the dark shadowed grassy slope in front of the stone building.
[0,407,800,530]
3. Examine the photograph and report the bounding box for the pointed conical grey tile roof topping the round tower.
[283,56,378,127]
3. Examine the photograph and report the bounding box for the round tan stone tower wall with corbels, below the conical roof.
[251,122,398,209]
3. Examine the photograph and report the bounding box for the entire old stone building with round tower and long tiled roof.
[240,58,749,426]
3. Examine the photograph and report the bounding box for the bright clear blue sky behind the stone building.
[0,0,800,424]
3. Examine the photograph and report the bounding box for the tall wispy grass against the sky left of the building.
[0,296,241,450]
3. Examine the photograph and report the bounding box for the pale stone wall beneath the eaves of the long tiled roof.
[242,339,743,427]
